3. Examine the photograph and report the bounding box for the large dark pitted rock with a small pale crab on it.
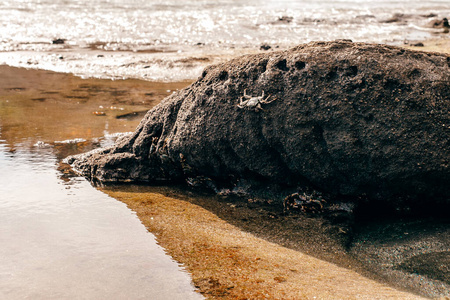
[70,41,450,210]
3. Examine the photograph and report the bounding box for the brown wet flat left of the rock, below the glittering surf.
[0,66,190,144]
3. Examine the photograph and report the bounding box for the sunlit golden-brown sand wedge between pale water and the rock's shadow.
[103,188,420,299]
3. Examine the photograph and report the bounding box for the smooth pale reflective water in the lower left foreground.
[0,141,202,300]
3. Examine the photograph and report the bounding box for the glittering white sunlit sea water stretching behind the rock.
[0,0,450,81]
